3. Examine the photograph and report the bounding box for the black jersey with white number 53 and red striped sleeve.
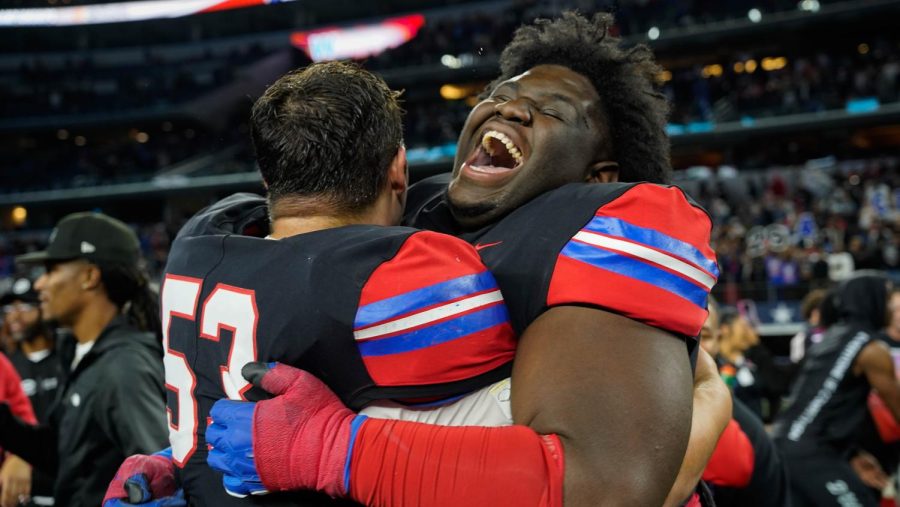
[160,194,515,506]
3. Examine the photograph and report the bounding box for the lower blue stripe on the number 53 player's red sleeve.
[357,304,509,357]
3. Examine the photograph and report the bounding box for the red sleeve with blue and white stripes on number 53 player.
[353,232,515,386]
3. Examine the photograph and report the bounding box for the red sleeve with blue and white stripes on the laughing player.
[547,184,719,336]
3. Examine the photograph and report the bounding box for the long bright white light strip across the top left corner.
[0,0,294,26]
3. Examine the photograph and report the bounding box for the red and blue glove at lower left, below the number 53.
[103,448,187,507]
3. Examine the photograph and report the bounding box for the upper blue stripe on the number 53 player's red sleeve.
[353,271,497,329]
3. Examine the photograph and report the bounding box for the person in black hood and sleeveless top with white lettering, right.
[773,273,900,507]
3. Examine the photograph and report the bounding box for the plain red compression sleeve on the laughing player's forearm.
[348,419,565,507]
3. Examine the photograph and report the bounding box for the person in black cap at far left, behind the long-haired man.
[0,278,61,505]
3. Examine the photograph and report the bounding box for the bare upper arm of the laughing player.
[512,306,692,506]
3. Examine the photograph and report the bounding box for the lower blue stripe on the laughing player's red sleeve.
[562,241,707,308]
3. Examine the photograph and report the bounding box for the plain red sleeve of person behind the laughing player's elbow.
[702,419,756,488]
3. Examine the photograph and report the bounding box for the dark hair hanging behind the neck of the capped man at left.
[97,263,162,339]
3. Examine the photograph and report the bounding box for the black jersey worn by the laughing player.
[405,175,718,343]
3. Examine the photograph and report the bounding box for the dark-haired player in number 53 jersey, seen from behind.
[107,63,515,506]
